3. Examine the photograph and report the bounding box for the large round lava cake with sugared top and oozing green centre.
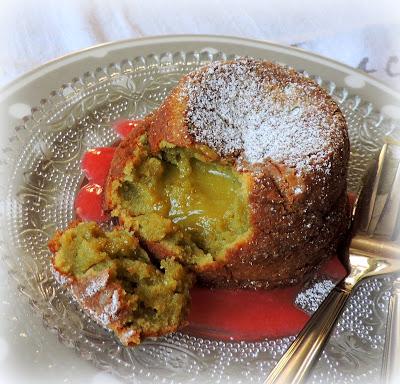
[105,59,349,288]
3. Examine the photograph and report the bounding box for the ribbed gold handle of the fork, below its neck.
[264,280,353,384]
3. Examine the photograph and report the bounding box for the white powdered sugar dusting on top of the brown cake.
[182,59,338,170]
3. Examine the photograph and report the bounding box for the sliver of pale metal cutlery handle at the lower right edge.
[382,278,400,384]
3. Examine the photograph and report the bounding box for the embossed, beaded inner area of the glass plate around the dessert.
[3,52,395,383]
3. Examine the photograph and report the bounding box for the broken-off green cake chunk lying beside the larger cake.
[49,222,194,346]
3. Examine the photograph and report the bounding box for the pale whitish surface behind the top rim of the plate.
[0,0,400,89]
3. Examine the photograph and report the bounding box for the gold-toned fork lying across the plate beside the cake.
[264,144,400,384]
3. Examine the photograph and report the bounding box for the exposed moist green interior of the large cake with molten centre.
[112,137,249,265]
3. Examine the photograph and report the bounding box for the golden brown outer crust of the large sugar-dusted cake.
[106,59,349,288]
